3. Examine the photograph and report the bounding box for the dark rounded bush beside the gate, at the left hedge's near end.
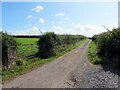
[38,32,59,58]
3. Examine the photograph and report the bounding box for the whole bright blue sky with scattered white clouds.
[0,2,118,36]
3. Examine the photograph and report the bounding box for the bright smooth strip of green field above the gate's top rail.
[15,38,39,44]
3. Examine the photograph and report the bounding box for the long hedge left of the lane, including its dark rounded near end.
[38,32,85,58]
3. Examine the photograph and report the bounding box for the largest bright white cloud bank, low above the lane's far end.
[51,24,115,37]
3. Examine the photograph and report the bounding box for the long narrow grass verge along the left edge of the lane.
[2,39,87,81]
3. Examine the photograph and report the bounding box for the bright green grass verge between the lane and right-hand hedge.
[88,41,102,64]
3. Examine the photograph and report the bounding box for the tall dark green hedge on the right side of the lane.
[88,28,120,67]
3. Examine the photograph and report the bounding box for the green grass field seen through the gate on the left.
[15,38,39,58]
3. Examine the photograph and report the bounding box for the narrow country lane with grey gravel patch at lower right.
[2,40,120,88]
